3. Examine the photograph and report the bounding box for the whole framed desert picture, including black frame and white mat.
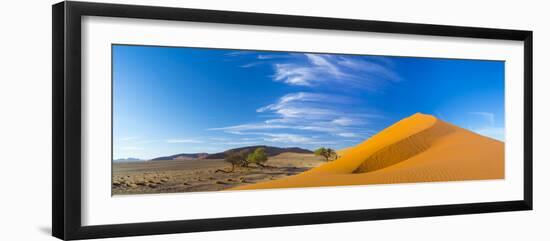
[52,1,533,239]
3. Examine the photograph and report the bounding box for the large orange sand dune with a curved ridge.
[234,113,504,189]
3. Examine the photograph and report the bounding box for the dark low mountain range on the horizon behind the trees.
[151,146,313,161]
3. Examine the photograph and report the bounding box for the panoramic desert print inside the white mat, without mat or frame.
[111,45,505,195]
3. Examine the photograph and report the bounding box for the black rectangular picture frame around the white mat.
[52,1,533,240]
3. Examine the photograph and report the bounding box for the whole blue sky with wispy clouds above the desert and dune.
[113,45,504,159]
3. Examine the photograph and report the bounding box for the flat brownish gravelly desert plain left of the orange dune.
[112,153,326,195]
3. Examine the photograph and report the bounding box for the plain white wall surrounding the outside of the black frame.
[0,0,550,240]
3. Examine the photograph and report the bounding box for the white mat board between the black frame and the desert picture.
[82,17,523,225]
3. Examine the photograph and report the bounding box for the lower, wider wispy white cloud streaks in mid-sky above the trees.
[209,92,383,142]
